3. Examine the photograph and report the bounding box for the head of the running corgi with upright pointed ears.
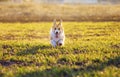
[52,20,63,36]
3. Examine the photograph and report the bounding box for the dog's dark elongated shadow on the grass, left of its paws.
[17,45,52,56]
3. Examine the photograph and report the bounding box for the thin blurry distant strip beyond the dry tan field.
[0,0,120,4]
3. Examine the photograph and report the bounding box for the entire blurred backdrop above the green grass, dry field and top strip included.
[0,0,120,22]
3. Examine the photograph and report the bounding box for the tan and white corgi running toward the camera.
[50,20,65,47]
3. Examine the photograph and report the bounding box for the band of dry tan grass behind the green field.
[0,3,120,22]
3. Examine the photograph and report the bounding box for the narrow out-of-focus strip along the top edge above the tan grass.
[0,0,120,4]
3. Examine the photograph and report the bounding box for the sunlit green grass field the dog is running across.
[0,22,120,77]
